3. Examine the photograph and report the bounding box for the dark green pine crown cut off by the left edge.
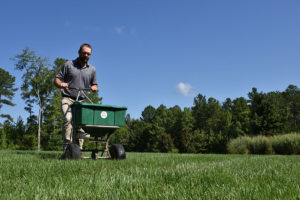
[0,68,18,121]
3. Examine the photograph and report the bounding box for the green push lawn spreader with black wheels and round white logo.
[64,88,127,160]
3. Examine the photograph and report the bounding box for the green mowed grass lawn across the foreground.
[0,150,300,199]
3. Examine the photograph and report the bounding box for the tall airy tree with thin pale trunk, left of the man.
[13,48,54,151]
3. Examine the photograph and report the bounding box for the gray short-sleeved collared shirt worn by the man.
[56,59,97,99]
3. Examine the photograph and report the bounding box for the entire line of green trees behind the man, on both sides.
[0,48,300,153]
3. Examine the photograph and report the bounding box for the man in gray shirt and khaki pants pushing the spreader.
[54,44,98,150]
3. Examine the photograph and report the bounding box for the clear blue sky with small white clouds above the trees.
[0,0,300,120]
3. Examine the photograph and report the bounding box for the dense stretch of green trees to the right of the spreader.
[114,85,300,153]
